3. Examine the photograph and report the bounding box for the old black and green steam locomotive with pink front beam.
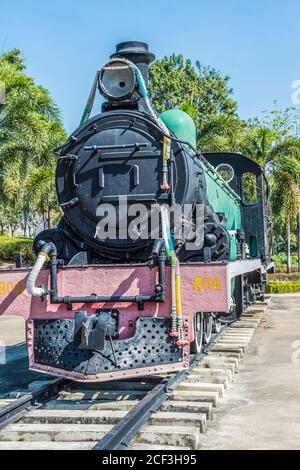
[0,41,271,381]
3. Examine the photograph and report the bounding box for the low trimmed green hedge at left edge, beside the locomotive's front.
[0,236,35,261]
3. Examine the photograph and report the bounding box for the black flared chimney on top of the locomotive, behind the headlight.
[110,41,155,85]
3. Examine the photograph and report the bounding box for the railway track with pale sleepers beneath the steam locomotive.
[0,302,267,450]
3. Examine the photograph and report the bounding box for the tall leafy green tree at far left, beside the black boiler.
[0,50,66,236]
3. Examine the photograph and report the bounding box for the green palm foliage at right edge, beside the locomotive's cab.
[241,105,300,258]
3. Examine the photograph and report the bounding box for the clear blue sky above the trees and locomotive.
[0,0,300,132]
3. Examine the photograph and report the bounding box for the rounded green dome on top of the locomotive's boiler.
[160,108,196,147]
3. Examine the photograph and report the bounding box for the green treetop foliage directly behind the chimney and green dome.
[149,54,244,151]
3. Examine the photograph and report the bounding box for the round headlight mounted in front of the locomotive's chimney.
[99,59,136,100]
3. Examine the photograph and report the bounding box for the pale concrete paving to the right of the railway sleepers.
[201,295,300,449]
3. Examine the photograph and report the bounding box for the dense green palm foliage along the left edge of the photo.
[0,50,66,235]
